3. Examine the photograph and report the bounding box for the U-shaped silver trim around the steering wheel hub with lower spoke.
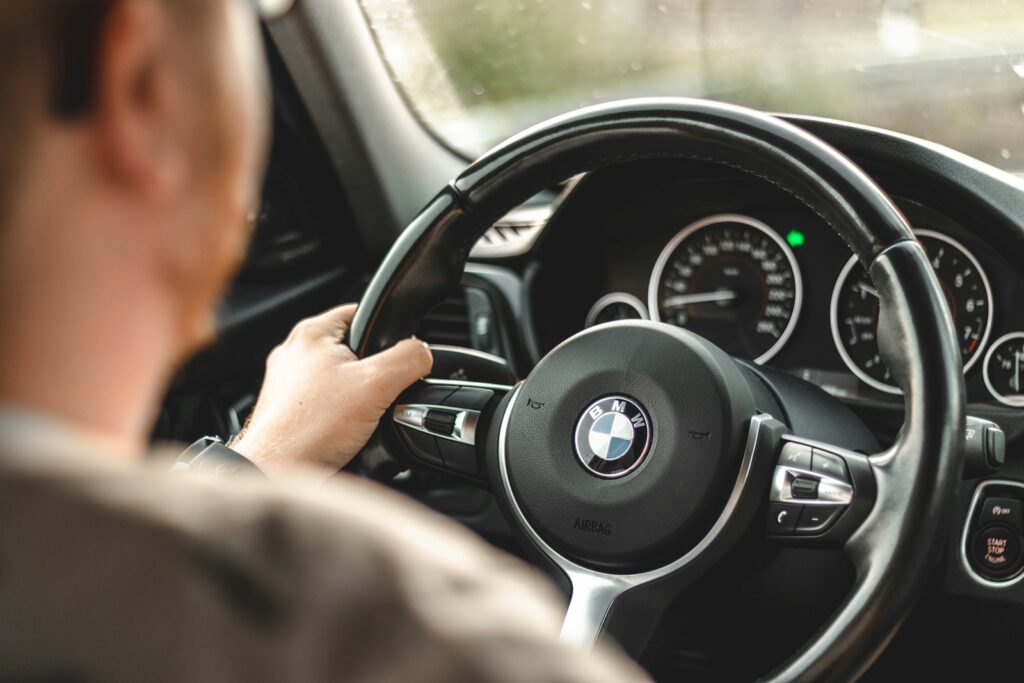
[498,387,774,649]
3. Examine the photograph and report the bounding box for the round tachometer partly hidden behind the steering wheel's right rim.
[831,230,992,393]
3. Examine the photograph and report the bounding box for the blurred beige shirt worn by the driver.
[0,411,645,683]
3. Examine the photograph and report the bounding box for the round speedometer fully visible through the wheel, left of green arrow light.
[648,214,803,362]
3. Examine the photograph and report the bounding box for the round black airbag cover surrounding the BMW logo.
[505,322,755,571]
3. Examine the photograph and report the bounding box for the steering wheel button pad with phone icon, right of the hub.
[767,435,878,547]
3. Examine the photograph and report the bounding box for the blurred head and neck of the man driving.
[0,0,268,443]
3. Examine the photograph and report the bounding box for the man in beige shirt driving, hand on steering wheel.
[0,0,642,681]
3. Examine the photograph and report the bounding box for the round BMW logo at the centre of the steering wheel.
[575,396,651,479]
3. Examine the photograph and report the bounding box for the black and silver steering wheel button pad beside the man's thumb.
[387,379,512,486]
